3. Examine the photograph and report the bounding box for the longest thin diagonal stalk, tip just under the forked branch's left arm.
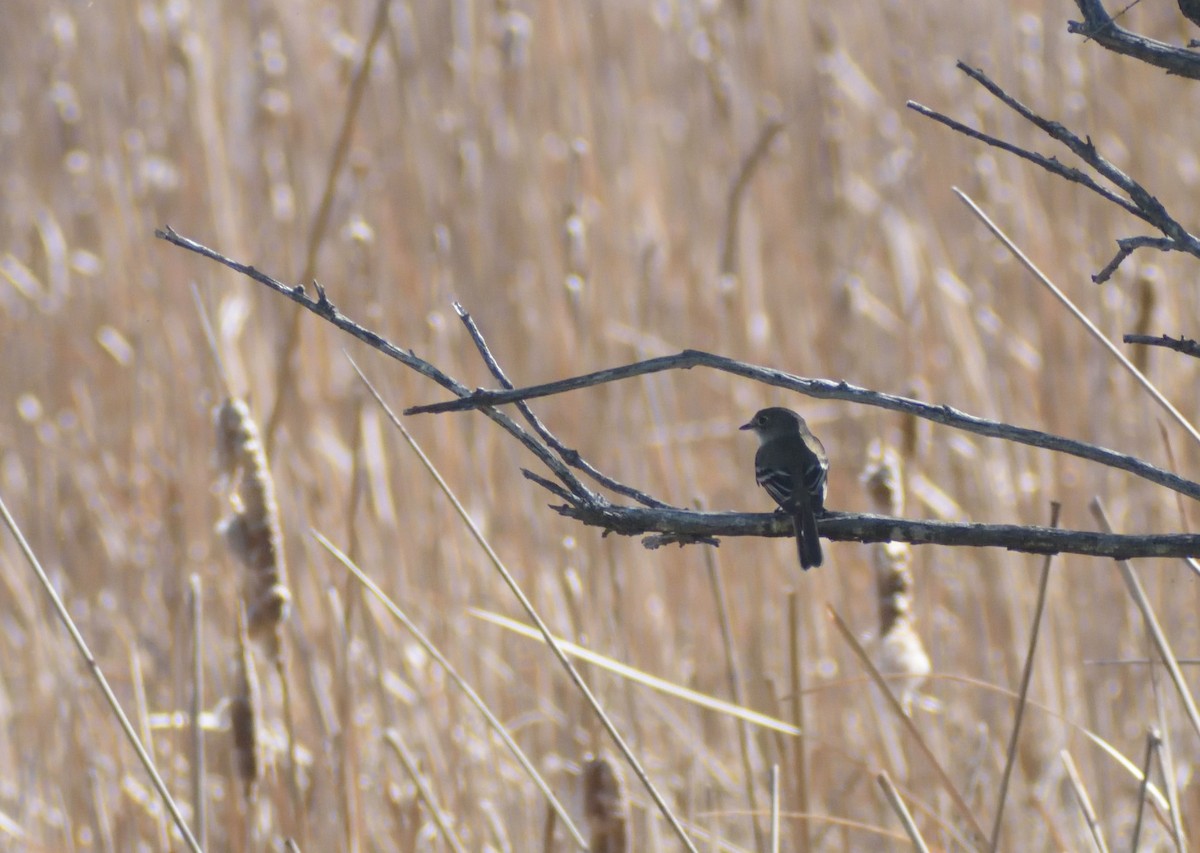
[349,359,696,853]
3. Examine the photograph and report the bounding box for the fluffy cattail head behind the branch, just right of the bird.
[863,440,930,708]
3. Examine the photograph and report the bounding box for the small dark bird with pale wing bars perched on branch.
[739,407,829,571]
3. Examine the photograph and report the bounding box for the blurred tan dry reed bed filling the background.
[0,0,1200,851]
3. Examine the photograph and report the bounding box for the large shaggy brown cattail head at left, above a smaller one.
[216,398,292,659]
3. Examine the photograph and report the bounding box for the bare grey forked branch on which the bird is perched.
[156,228,1200,558]
